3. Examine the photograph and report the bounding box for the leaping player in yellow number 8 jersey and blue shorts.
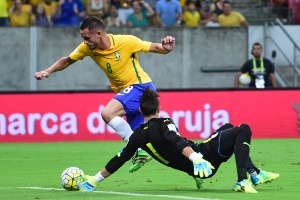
[34,17,175,172]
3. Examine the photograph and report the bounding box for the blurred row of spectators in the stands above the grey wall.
[0,0,298,27]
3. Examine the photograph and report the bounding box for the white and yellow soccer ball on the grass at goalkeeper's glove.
[60,167,84,191]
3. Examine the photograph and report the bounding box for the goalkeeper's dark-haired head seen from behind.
[140,87,159,116]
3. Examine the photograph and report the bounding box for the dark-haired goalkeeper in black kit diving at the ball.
[79,88,279,193]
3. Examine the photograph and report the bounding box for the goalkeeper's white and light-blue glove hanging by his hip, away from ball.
[189,152,215,178]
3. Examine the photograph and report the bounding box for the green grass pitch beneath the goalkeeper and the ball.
[0,139,300,200]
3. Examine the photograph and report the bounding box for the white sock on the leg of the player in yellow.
[108,116,133,142]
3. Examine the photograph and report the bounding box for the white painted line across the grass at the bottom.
[9,187,219,200]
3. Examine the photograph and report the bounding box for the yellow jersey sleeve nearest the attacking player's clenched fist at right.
[126,35,152,53]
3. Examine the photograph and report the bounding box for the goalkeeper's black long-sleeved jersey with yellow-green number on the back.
[105,118,194,175]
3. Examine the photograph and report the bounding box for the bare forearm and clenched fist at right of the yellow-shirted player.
[149,36,175,54]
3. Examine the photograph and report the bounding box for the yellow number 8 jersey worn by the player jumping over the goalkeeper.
[69,34,151,92]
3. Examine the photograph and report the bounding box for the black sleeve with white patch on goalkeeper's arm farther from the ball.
[162,118,190,152]
